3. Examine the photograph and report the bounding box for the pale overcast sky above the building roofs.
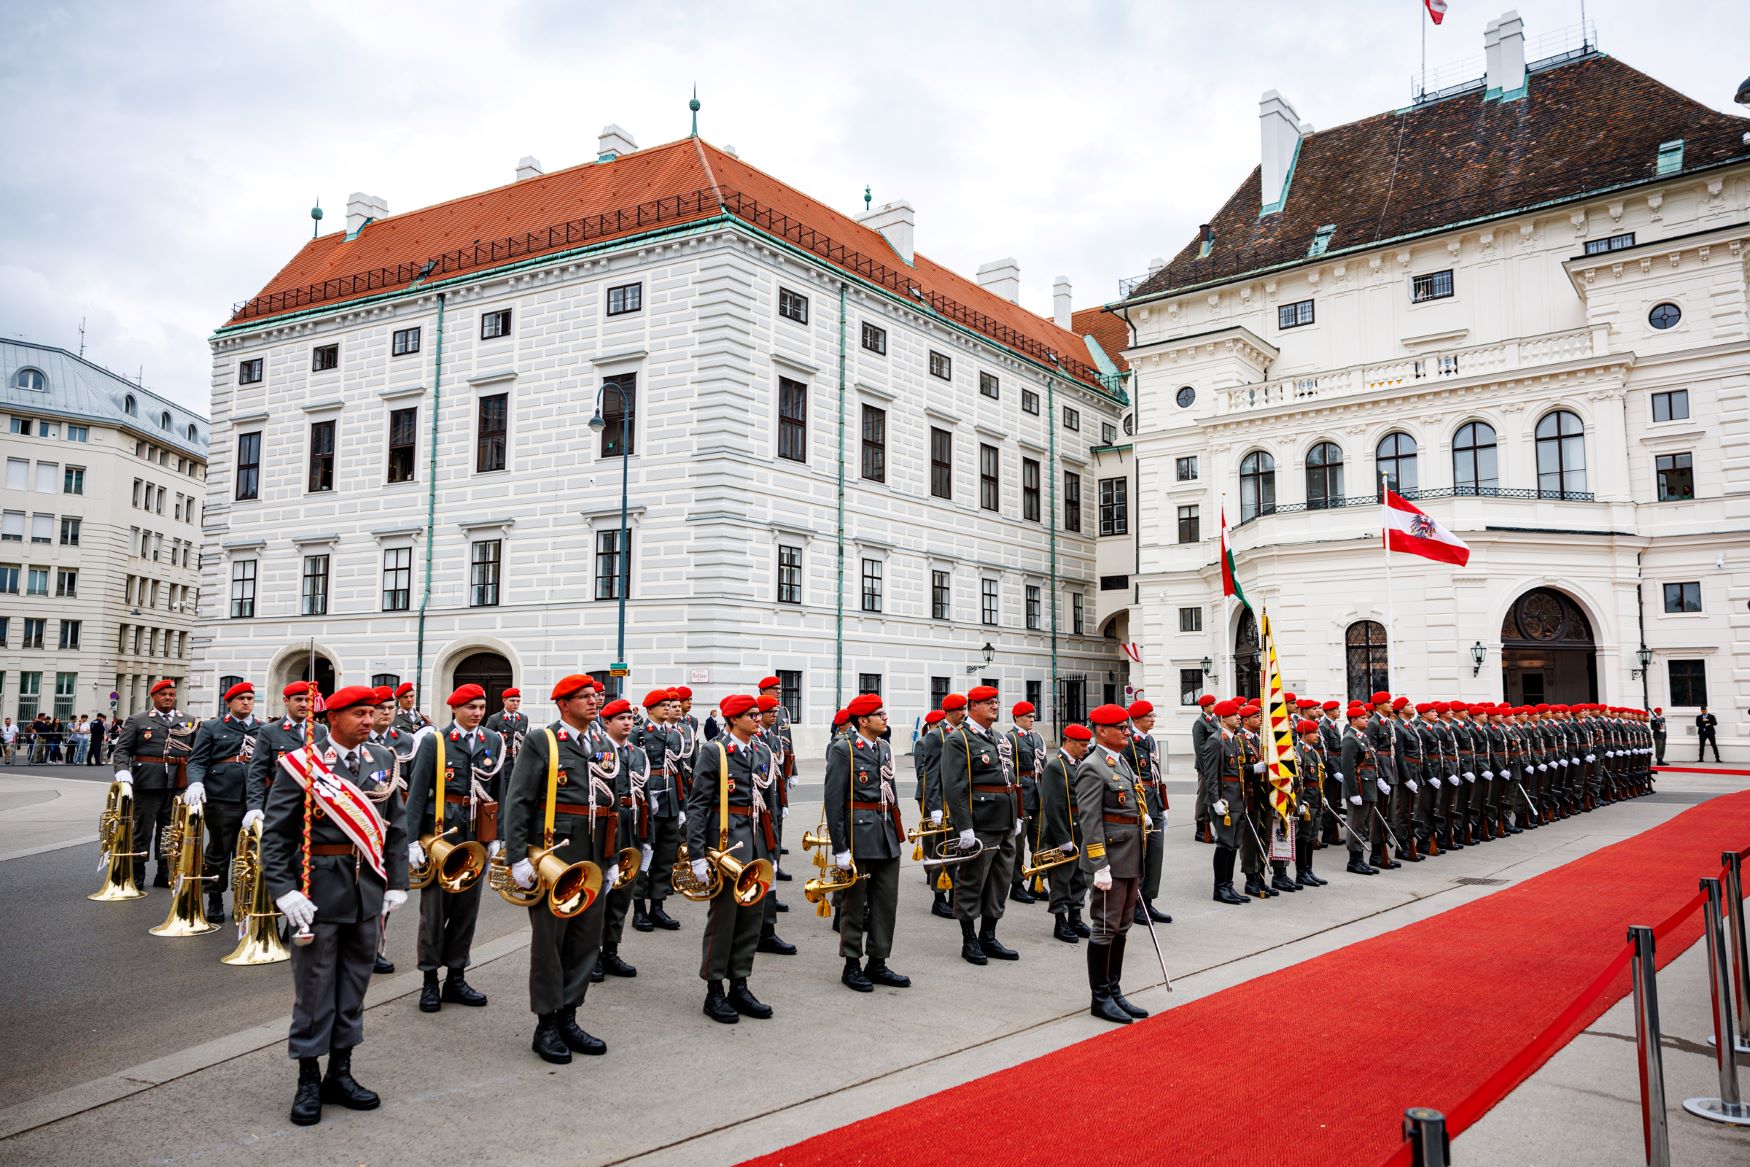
[0,0,1750,409]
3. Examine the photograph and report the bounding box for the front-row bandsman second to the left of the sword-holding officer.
[942,684,1022,964]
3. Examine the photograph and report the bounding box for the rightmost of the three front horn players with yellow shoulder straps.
[686,693,777,1025]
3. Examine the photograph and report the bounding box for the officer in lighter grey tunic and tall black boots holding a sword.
[1076,705,1148,1025]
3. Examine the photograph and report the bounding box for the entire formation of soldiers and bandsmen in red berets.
[91,674,1654,1125]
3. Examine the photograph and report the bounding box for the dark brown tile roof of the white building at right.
[1131,52,1750,299]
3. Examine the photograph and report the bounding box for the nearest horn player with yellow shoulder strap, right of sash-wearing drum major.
[504,674,620,1066]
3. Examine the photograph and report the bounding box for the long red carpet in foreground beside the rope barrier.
[749,791,1750,1167]
